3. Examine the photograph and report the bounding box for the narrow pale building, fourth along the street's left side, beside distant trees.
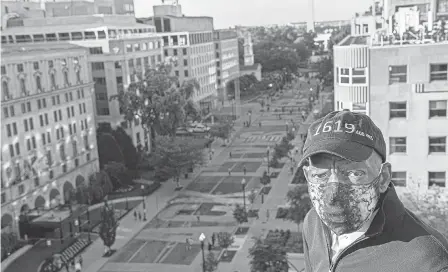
[214,29,240,104]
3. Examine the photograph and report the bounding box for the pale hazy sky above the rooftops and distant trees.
[134,0,373,28]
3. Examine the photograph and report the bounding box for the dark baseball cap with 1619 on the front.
[299,110,386,166]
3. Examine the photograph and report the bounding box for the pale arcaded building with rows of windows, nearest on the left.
[1,43,98,237]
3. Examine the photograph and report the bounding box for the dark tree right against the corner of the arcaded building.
[97,132,124,168]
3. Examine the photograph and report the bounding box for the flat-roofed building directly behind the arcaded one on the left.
[2,15,163,150]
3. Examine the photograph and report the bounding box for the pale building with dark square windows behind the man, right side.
[334,1,448,190]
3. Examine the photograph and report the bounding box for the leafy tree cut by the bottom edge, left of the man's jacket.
[249,237,289,272]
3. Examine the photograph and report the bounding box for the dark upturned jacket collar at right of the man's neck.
[365,183,406,237]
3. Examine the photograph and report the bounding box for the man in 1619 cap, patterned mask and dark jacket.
[299,111,448,272]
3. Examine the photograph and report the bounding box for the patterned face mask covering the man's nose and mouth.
[308,177,380,235]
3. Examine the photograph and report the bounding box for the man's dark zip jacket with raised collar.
[303,185,448,272]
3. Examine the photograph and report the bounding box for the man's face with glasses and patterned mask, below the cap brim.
[304,154,381,235]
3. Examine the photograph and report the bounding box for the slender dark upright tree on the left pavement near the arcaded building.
[99,201,118,255]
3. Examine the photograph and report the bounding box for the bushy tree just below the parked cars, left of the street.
[152,136,206,188]
